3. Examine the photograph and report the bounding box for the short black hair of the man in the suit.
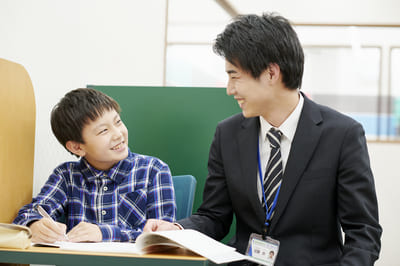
[213,13,304,89]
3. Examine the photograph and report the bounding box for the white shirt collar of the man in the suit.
[260,93,304,142]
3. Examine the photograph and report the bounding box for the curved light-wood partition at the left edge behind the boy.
[0,58,36,223]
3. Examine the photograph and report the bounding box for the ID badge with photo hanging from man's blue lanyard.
[246,233,279,266]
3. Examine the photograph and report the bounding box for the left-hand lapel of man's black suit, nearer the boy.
[237,117,265,222]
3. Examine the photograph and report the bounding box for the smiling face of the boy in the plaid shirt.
[79,110,128,170]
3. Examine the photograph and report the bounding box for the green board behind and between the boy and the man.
[87,85,241,210]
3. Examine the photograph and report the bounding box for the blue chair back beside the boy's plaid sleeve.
[172,175,197,220]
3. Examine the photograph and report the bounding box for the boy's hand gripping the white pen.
[29,218,67,243]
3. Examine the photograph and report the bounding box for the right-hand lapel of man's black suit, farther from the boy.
[271,95,322,230]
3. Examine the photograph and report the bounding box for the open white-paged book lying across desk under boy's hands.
[37,229,260,264]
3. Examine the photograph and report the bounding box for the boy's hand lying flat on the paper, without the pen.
[67,222,103,242]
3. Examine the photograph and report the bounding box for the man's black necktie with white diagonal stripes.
[264,128,283,218]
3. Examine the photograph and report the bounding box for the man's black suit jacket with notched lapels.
[179,96,382,265]
